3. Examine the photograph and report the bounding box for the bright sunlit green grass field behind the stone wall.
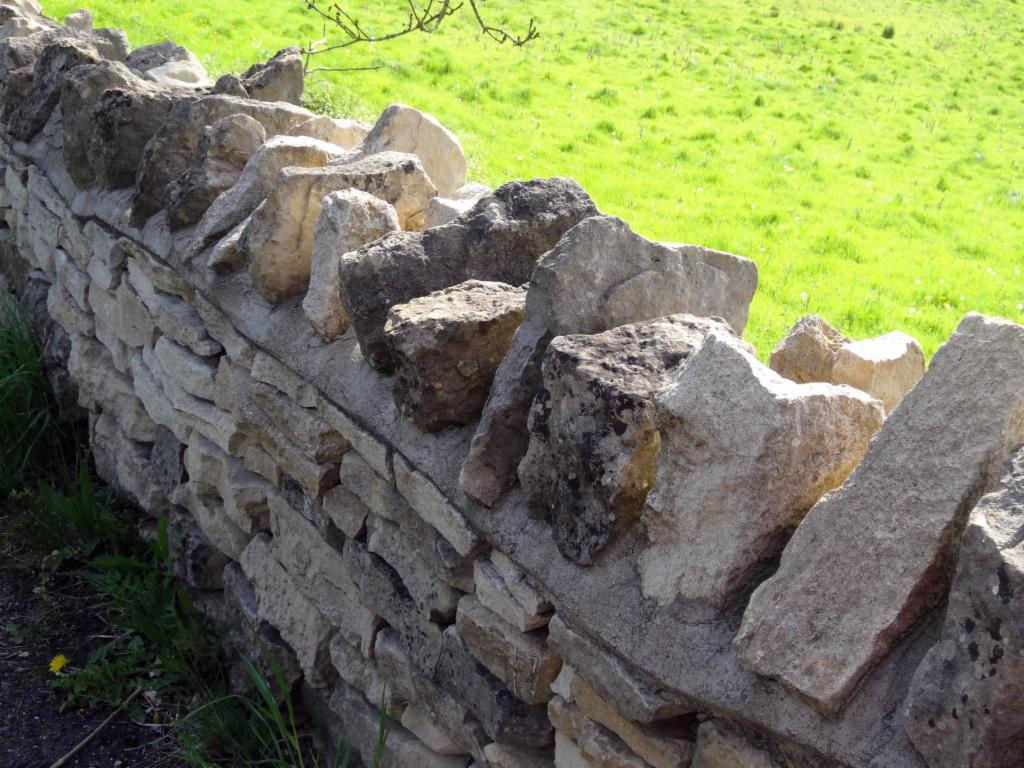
[45,0,1024,355]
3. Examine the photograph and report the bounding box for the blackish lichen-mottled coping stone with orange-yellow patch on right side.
[518,314,745,564]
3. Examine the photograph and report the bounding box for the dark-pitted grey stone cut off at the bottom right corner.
[906,447,1024,768]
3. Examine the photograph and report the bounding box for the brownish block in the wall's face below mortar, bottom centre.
[456,595,562,705]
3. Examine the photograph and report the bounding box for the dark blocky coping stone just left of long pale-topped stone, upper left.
[89,81,179,189]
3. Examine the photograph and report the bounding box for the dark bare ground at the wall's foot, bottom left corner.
[0,548,173,768]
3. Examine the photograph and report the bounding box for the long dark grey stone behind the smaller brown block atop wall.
[339,178,597,373]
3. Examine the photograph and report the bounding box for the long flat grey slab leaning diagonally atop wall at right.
[735,313,1024,717]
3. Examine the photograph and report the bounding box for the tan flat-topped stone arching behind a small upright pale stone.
[241,153,435,303]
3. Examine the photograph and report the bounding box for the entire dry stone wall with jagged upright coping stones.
[0,0,1024,768]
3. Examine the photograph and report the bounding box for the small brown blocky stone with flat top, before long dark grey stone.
[385,280,526,430]
